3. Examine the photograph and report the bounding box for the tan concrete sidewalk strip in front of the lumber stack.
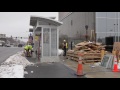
[60,57,120,78]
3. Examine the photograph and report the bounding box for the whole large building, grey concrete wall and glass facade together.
[59,12,120,48]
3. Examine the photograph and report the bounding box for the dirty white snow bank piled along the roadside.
[0,52,34,78]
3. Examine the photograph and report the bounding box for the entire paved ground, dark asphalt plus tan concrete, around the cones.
[24,57,120,78]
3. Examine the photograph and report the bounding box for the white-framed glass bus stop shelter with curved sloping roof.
[30,16,62,62]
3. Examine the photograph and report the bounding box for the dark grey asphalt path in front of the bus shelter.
[24,58,85,78]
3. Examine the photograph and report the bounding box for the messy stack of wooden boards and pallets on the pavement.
[67,42,105,63]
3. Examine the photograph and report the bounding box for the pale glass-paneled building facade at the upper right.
[96,12,120,44]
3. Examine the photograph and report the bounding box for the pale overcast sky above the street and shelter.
[0,12,58,41]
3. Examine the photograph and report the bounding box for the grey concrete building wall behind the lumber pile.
[59,12,95,47]
